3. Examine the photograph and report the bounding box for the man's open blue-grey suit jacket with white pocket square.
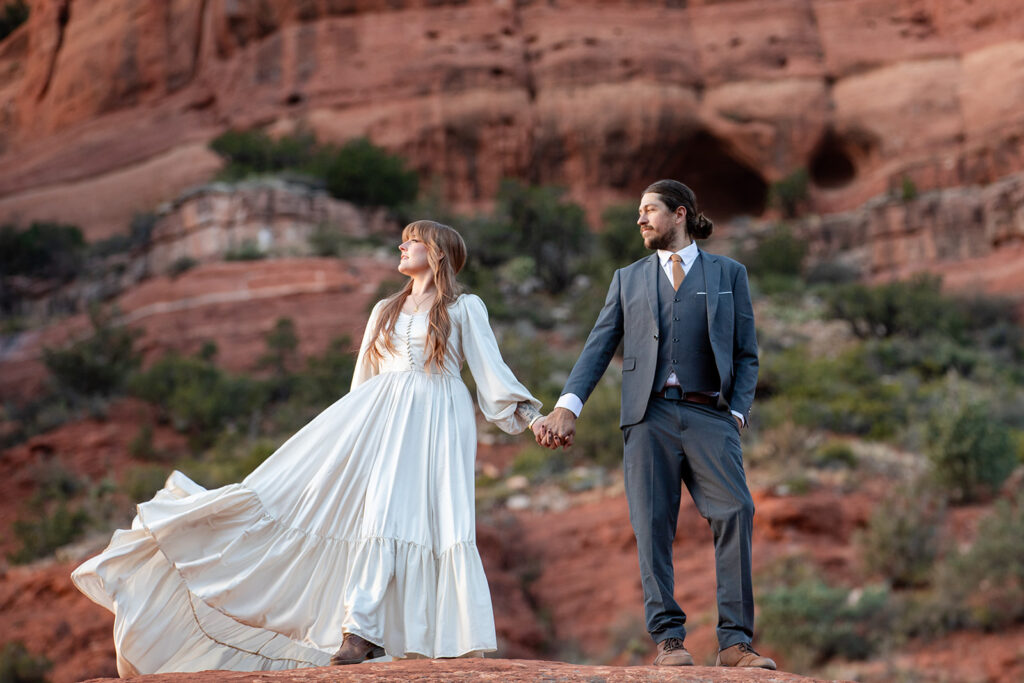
[562,251,758,427]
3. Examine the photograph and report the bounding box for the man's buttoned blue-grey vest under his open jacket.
[652,256,721,393]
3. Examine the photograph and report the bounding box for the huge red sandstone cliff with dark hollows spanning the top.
[0,0,1024,237]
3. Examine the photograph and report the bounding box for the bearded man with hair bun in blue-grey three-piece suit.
[538,180,775,669]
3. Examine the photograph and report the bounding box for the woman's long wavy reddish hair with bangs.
[367,220,466,370]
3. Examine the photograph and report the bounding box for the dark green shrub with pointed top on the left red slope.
[43,307,141,396]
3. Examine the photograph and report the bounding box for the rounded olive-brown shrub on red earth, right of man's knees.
[857,485,945,588]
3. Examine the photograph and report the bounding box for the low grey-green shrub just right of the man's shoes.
[758,579,892,671]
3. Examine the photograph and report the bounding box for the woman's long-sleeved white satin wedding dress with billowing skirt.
[72,294,540,676]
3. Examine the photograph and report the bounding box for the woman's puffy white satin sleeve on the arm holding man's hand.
[460,294,541,434]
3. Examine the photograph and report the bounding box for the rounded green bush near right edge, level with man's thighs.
[928,403,1017,503]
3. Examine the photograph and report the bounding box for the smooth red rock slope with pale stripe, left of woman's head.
[0,256,396,398]
